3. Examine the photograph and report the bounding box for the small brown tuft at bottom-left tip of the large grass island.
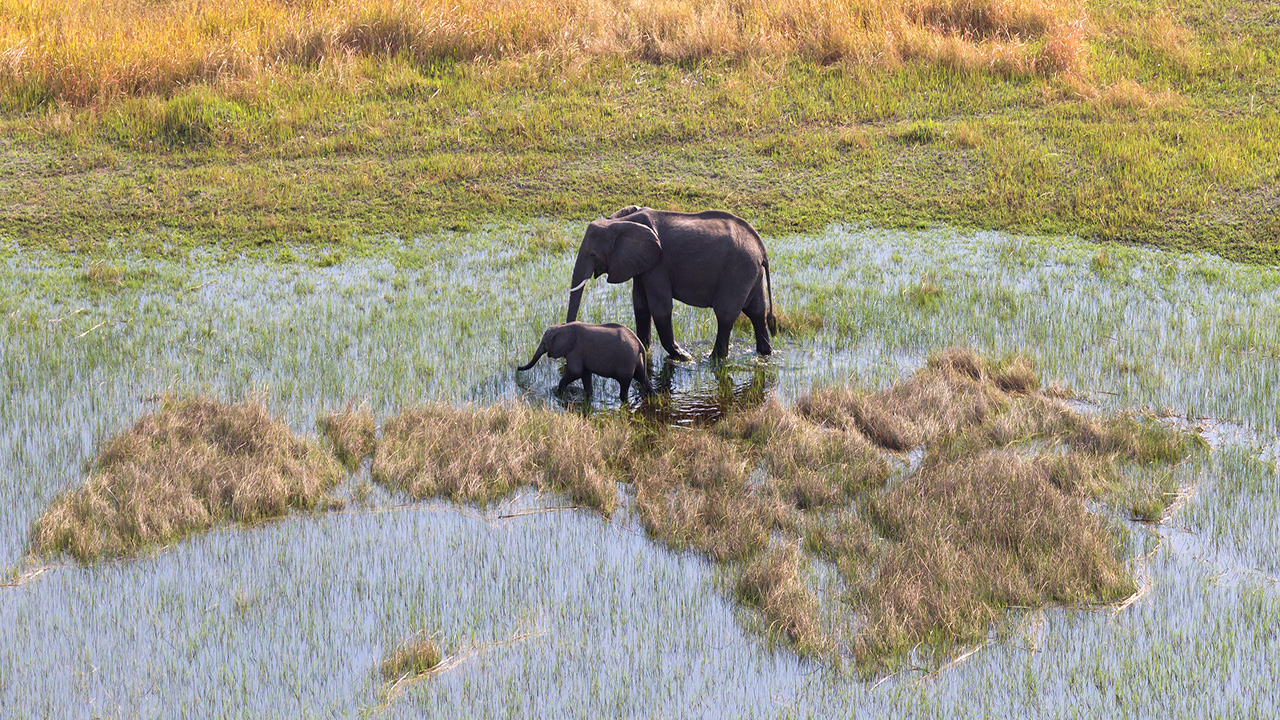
[733,547,823,655]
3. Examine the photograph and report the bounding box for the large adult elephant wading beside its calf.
[566,205,777,360]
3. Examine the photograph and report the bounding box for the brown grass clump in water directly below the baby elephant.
[372,405,630,514]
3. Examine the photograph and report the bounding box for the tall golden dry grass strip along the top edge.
[0,0,1089,104]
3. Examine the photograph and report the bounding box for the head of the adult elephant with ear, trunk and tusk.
[566,218,662,323]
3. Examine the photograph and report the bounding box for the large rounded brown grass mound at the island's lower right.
[859,451,1134,659]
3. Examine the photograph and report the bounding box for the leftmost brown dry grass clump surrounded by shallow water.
[32,397,342,562]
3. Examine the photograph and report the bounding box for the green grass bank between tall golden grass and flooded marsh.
[0,0,1280,263]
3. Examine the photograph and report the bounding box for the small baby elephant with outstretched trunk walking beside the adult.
[516,323,653,405]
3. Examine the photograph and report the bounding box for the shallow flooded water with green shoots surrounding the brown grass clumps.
[0,223,1280,717]
